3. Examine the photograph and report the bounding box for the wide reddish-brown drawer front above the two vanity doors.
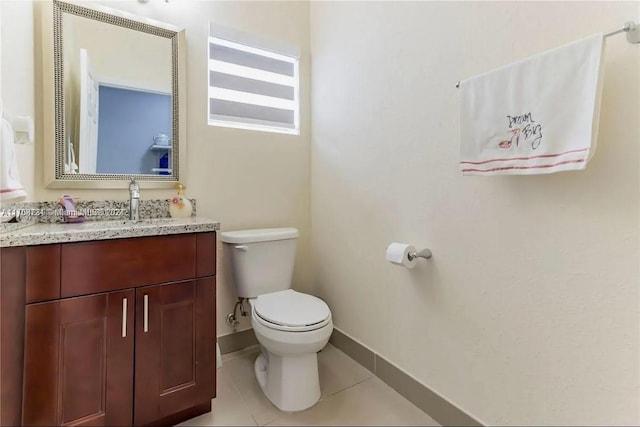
[60,234,196,298]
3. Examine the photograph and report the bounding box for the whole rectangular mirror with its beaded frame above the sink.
[41,0,186,188]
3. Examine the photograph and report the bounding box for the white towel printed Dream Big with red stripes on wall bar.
[460,33,604,175]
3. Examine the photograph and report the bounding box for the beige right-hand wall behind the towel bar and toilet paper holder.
[311,2,640,425]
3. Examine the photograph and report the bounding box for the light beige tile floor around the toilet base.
[180,344,439,426]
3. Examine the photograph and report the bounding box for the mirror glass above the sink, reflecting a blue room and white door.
[62,13,172,175]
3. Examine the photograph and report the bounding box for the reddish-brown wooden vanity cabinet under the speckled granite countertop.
[12,232,216,426]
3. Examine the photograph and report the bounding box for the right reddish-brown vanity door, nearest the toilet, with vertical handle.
[134,277,216,425]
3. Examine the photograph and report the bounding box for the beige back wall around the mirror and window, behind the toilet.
[1,0,311,335]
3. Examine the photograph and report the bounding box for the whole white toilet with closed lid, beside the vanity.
[220,228,333,411]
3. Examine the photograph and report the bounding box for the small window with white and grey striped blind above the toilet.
[208,24,300,135]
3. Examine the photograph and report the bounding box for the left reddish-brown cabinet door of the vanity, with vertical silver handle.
[22,290,134,426]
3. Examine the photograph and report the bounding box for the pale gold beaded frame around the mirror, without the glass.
[41,0,187,189]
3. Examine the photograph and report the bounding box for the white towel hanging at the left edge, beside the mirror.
[0,101,27,201]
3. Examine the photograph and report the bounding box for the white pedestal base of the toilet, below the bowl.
[254,348,320,412]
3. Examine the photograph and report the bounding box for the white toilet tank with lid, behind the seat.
[220,228,299,298]
